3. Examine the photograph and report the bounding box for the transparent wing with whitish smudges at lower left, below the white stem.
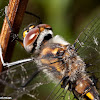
[0,62,54,100]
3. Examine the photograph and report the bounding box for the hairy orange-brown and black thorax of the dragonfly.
[39,36,85,81]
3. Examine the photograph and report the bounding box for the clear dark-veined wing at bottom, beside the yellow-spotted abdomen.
[46,79,77,100]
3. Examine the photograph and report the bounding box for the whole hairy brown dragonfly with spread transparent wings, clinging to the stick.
[0,6,100,100]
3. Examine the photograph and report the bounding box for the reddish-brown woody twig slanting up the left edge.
[0,0,28,72]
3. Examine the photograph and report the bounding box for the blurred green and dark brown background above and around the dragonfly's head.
[0,0,100,100]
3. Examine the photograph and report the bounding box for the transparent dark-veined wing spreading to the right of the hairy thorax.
[74,14,100,93]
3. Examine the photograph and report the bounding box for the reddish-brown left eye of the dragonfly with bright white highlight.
[23,28,39,52]
